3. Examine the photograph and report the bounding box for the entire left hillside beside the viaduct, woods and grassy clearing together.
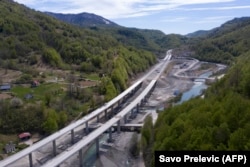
[0,0,156,136]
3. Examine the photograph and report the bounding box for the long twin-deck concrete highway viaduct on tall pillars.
[0,51,171,167]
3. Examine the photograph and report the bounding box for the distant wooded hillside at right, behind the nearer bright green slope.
[190,17,250,64]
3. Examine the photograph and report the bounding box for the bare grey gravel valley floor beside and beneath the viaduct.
[89,59,225,167]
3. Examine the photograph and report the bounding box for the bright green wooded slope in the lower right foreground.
[155,52,250,150]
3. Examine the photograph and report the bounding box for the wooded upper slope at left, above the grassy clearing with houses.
[0,0,156,88]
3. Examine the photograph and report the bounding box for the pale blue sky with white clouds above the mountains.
[15,0,250,35]
